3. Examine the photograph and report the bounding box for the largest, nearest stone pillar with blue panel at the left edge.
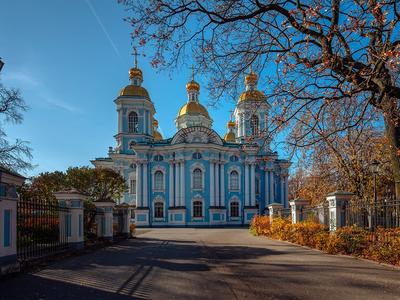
[0,168,25,275]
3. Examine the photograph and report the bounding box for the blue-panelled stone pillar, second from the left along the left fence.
[54,189,86,249]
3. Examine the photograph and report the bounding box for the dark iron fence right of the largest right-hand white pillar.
[342,199,400,230]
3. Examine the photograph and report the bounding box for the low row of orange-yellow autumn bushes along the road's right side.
[250,216,400,266]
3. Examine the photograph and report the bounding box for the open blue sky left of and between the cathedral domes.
[0,0,284,175]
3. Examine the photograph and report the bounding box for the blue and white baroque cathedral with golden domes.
[92,57,290,227]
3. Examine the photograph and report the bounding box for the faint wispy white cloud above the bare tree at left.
[4,71,81,113]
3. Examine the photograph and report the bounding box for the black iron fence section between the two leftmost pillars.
[17,198,71,262]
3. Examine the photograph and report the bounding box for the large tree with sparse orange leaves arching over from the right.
[119,0,400,199]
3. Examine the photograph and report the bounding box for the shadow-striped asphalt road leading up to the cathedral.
[0,229,400,300]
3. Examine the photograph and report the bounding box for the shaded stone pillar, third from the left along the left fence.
[93,201,115,241]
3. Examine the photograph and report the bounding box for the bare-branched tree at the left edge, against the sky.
[0,83,32,171]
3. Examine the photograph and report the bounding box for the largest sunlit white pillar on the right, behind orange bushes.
[326,191,354,231]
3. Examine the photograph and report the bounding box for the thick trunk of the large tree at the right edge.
[384,104,400,200]
